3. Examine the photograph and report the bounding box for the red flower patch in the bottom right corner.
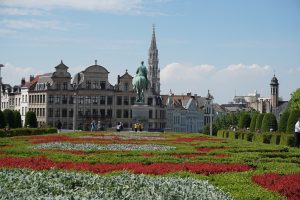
[252,173,300,200]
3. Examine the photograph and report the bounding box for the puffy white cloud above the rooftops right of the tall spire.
[161,63,273,103]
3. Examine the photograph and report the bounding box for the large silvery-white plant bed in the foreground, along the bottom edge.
[0,169,232,200]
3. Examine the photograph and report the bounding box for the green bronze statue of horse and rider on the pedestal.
[132,61,148,103]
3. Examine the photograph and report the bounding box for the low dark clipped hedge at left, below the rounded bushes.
[0,128,57,137]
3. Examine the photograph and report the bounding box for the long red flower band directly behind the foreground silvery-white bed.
[0,157,253,175]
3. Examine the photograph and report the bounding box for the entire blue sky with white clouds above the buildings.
[0,0,300,104]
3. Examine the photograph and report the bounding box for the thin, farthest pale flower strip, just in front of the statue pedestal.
[80,135,164,140]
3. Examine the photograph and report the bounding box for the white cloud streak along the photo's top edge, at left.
[0,0,143,13]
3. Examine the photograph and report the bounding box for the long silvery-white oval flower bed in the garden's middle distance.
[33,142,176,151]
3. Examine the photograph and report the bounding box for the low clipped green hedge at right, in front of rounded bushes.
[217,130,295,147]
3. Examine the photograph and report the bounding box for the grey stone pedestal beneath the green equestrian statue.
[131,104,150,131]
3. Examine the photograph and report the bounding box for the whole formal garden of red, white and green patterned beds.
[0,129,300,200]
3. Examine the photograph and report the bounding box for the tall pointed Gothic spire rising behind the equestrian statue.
[148,25,160,95]
